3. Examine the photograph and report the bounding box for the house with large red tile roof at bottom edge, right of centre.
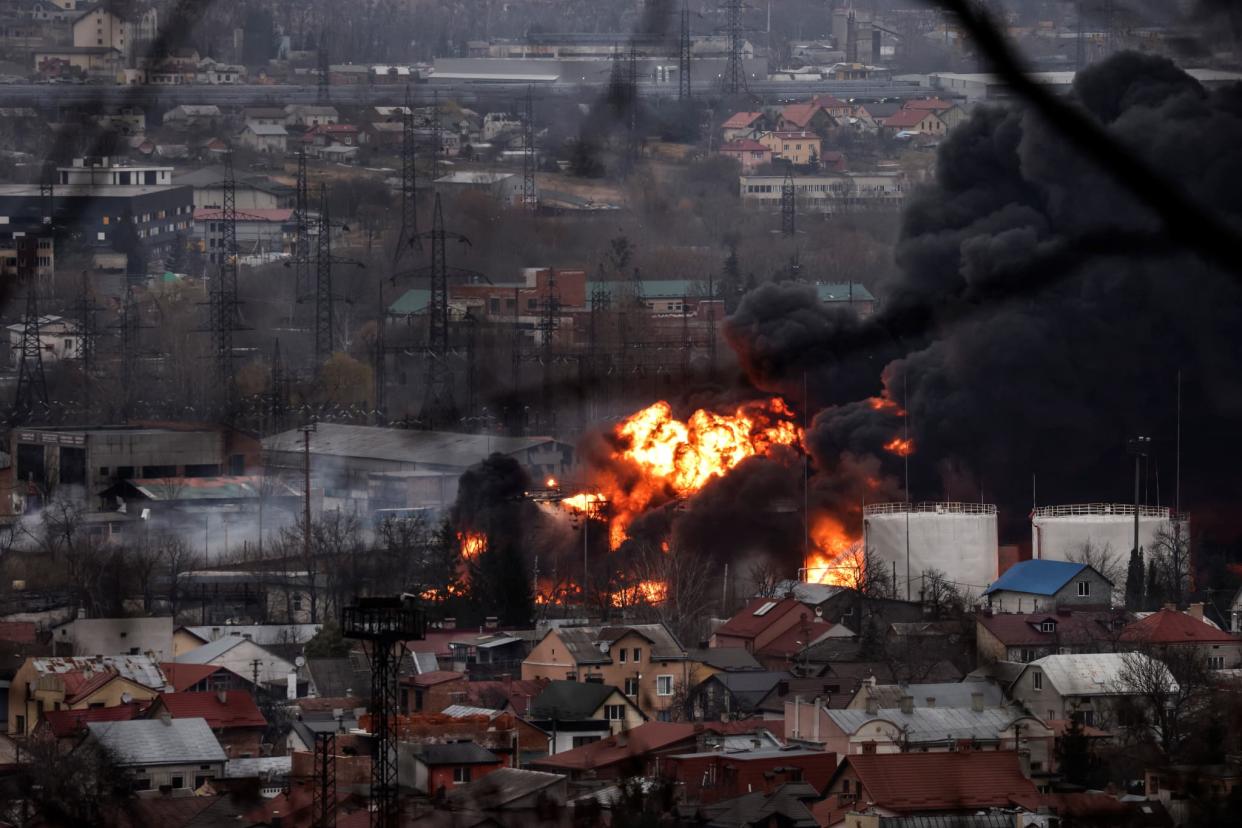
[814,751,1040,828]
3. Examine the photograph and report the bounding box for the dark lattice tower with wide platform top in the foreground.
[340,597,425,828]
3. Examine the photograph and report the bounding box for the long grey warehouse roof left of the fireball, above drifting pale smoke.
[263,422,559,468]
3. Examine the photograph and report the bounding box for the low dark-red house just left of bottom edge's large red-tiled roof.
[658,747,837,803]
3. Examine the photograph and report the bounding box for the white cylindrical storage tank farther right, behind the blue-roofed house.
[1031,503,1189,576]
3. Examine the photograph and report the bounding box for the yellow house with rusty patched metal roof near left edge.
[9,655,171,736]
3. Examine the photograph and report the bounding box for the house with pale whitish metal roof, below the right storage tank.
[1009,653,1177,730]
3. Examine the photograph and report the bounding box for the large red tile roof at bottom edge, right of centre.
[830,751,1040,813]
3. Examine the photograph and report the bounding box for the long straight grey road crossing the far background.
[0,81,927,109]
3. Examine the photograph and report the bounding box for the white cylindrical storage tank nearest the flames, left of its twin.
[863,503,999,600]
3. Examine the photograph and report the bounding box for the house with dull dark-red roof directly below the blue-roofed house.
[975,608,1129,663]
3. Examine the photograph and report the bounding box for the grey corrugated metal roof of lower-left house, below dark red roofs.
[87,719,229,767]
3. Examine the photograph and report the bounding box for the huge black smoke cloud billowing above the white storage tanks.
[727,53,1242,539]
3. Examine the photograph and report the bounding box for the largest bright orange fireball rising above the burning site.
[583,397,802,549]
